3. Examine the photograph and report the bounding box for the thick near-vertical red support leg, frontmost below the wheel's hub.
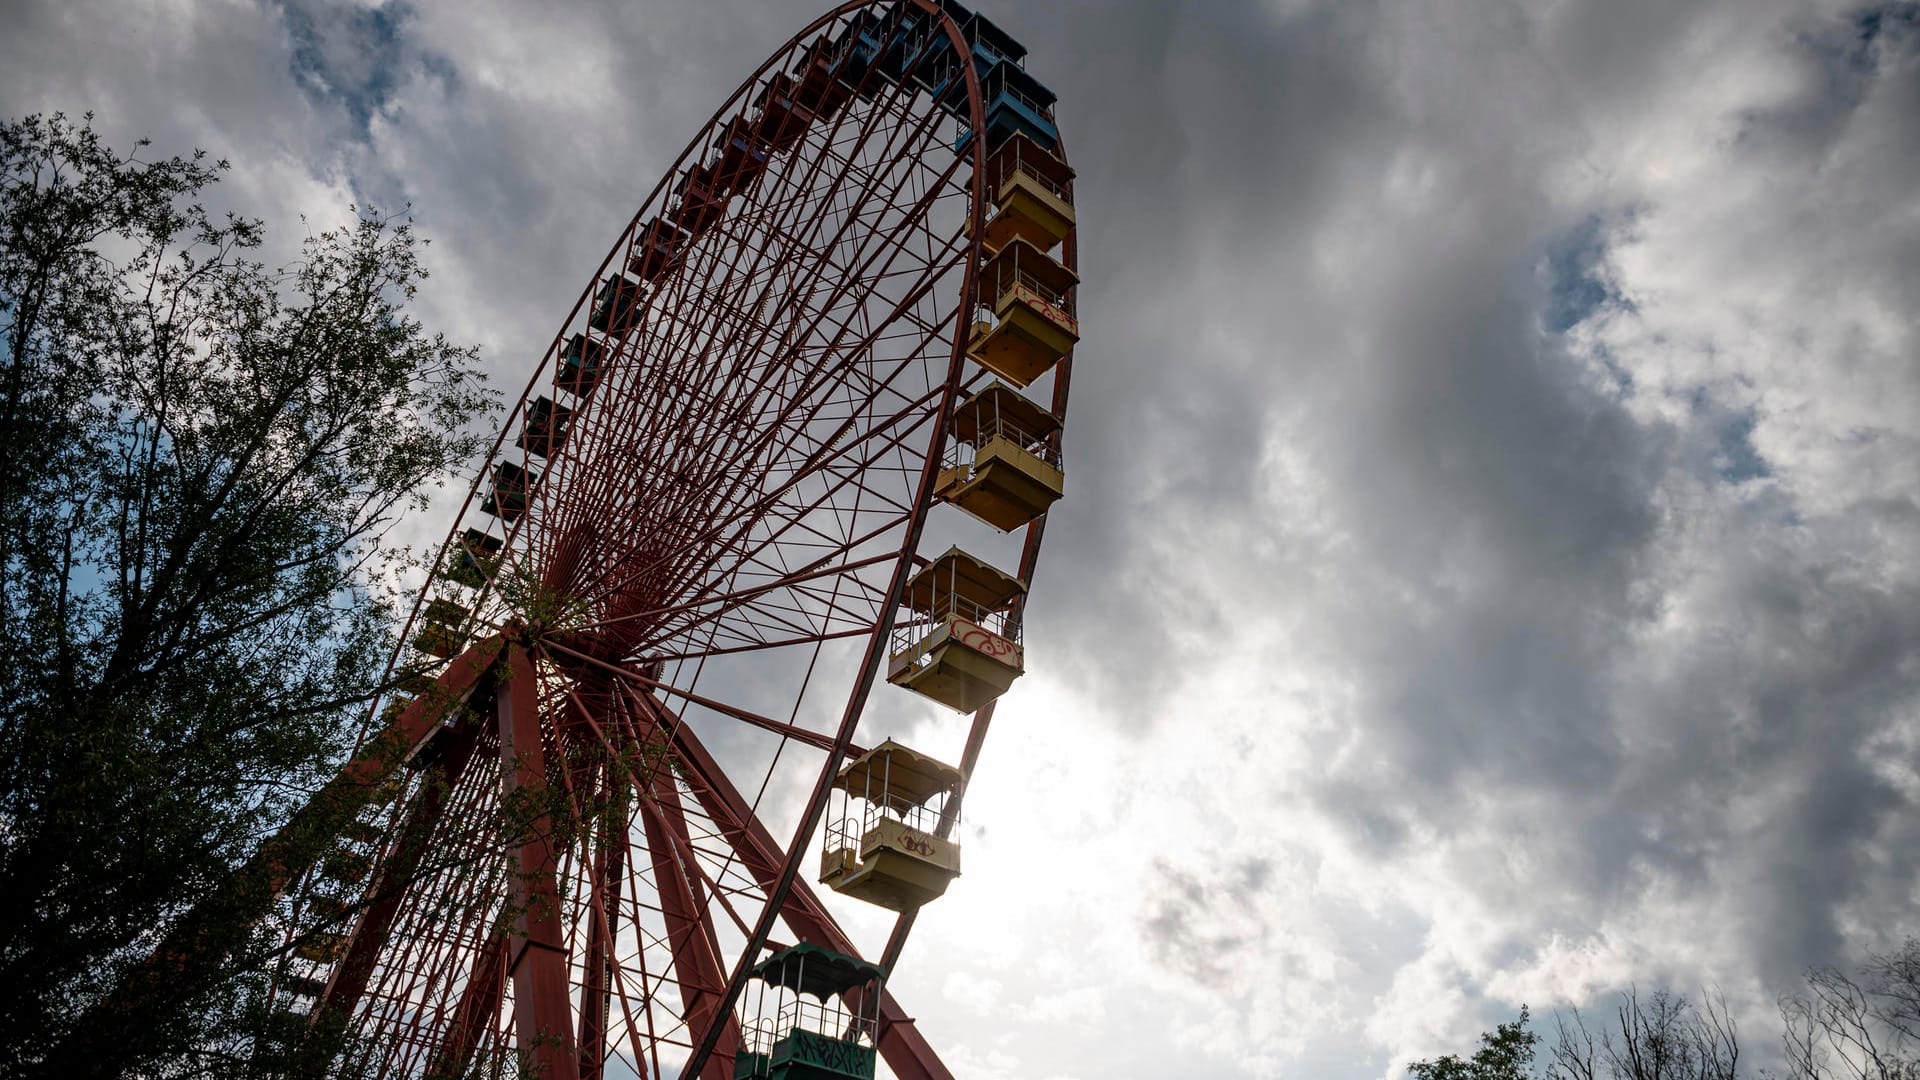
[495,642,580,1080]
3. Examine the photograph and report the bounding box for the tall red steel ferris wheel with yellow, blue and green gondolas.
[251,0,1079,1080]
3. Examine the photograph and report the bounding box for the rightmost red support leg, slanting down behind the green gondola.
[639,696,954,1080]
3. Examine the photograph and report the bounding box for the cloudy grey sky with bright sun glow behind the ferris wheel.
[0,0,1920,1080]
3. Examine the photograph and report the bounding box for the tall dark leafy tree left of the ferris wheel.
[0,115,493,1074]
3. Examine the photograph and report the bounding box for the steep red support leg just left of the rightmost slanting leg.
[641,769,739,1080]
